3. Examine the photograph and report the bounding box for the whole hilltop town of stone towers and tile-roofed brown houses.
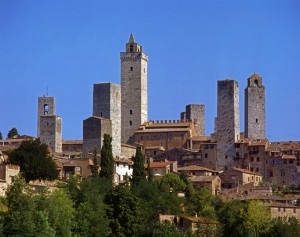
[0,34,300,234]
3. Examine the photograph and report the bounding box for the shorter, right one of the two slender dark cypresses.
[132,146,146,186]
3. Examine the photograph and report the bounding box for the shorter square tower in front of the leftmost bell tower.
[40,115,62,153]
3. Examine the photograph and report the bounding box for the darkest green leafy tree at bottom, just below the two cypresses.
[104,186,142,237]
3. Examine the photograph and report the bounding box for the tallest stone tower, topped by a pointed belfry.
[120,34,148,144]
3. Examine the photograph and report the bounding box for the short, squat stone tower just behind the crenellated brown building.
[185,104,205,136]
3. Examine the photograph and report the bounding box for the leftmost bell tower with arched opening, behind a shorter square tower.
[37,96,56,137]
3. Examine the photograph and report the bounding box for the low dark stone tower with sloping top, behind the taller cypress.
[82,116,112,157]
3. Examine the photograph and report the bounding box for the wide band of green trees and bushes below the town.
[0,175,300,237]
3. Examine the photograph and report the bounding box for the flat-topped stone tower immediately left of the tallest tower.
[93,83,121,157]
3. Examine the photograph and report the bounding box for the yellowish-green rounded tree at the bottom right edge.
[245,200,271,237]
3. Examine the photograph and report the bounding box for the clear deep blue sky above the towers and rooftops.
[0,0,300,141]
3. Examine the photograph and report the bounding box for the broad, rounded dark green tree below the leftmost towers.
[8,139,59,183]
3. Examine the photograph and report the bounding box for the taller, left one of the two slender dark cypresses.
[100,134,114,181]
